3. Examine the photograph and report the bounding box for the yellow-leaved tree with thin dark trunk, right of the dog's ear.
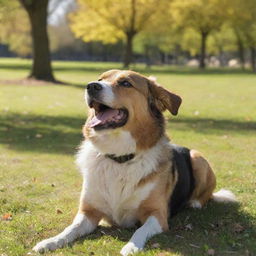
[171,0,223,68]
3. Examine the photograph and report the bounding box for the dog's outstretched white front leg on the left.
[33,207,100,253]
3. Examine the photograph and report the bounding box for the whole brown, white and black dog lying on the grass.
[33,70,235,255]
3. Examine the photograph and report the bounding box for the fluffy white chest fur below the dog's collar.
[77,141,164,226]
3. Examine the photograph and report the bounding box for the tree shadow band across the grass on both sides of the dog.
[0,113,256,154]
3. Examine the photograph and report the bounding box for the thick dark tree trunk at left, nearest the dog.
[20,0,55,81]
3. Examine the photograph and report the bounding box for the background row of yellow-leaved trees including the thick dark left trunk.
[0,0,256,73]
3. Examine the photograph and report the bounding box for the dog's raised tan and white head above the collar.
[84,70,181,154]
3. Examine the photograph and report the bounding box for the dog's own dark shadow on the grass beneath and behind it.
[77,202,256,256]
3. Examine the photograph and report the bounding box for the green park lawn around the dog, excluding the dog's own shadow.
[0,59,256,256]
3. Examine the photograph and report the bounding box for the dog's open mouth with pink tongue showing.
[88,101,128,130]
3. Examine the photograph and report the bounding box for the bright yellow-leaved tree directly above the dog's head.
[70,0,166,67]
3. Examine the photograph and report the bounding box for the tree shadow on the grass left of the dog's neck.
[0,113,85,154]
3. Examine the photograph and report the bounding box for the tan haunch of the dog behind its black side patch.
[189,150,216,208]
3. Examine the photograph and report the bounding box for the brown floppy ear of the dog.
[148,77,182,116]
